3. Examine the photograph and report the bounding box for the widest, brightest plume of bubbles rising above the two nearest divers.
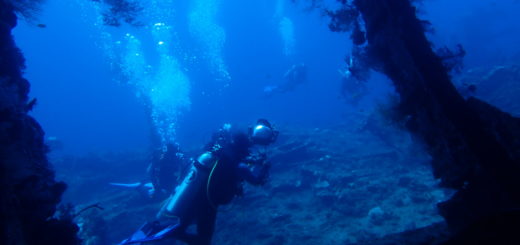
[78,1,191,150]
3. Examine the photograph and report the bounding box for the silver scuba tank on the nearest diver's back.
[157,152,217,220]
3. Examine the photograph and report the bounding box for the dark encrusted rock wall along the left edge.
[0,1,78,244]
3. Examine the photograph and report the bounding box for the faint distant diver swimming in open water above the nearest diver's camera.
[264,63,307,96]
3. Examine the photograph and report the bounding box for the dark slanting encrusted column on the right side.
[331,0,520,238]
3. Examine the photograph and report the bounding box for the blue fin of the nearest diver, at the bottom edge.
[119,222,179,245]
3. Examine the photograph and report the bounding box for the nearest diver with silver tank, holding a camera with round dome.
[121,119,278,245]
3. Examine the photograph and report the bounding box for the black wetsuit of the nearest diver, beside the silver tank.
[174,133,267,245]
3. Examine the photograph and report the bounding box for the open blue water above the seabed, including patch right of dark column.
[15,0,520,155]
